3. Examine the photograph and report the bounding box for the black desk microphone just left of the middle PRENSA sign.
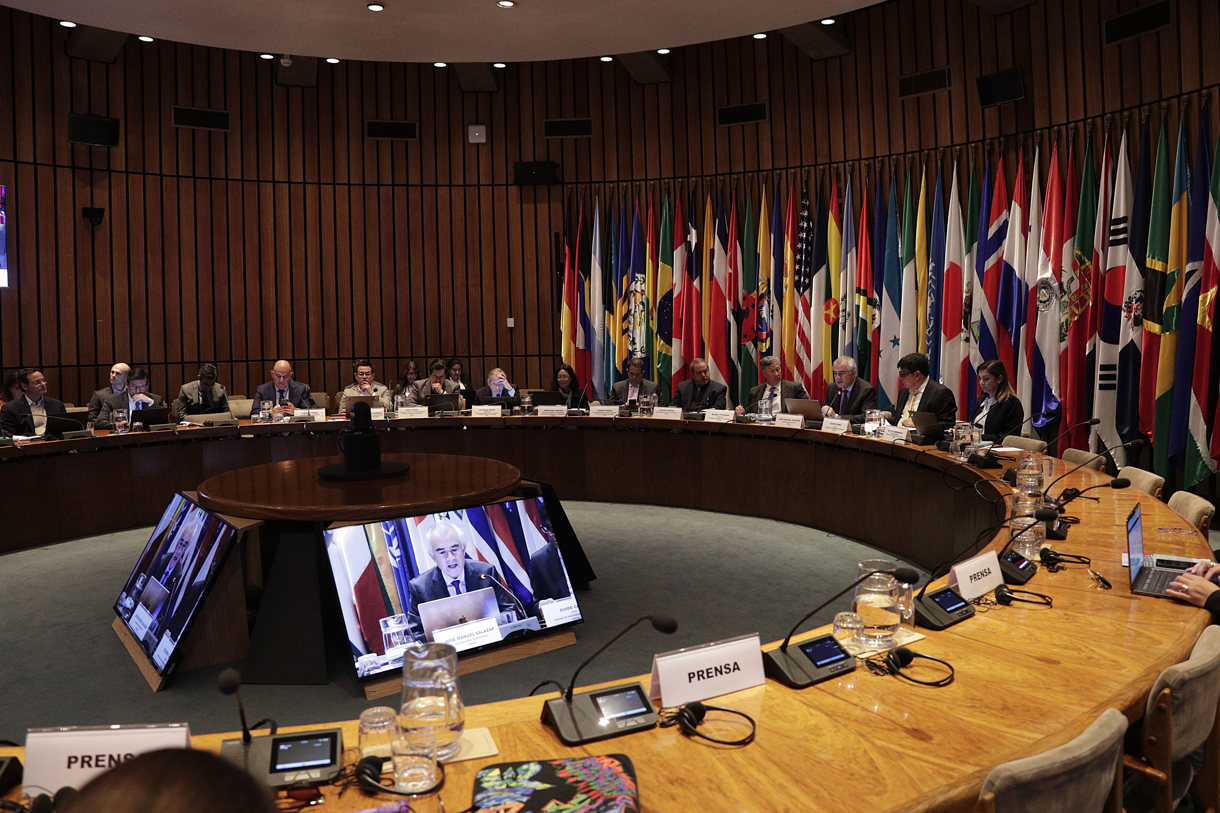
[542,613,678,745]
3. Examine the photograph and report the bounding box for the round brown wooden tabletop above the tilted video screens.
[199,454,521,522]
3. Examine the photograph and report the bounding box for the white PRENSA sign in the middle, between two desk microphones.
[651,634,764,708]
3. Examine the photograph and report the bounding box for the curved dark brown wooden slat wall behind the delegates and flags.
[0,0,1220,403]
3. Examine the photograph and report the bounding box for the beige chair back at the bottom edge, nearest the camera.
[975,708,1127,813]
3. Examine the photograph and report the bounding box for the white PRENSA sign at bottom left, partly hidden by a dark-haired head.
[22,723,190,796]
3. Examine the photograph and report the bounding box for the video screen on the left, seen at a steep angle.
[115,494,237,675]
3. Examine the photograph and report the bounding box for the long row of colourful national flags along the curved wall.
[560,115,1220,487]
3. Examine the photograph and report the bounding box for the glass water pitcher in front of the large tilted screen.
[399,643,466,759]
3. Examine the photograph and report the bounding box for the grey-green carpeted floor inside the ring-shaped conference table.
[0,503,922,742]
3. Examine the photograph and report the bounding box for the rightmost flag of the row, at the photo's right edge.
[1171,116,1220,480]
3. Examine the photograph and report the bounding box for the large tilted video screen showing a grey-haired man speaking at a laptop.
[326,497,581,678]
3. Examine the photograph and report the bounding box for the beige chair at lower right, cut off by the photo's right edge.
[1122,626,1220,813]
